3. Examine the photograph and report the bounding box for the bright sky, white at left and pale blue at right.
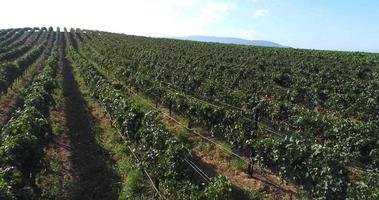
[0,0,379,52]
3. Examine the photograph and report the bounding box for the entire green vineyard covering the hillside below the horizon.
[0,27,379,200]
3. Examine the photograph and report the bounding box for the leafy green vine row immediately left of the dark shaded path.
[0,29,59,199]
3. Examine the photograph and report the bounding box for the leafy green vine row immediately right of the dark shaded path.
[69,34,231,200]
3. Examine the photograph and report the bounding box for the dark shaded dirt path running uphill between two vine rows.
[57,36,118,199]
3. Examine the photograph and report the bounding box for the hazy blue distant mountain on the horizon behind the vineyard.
[171,35,285,48]
